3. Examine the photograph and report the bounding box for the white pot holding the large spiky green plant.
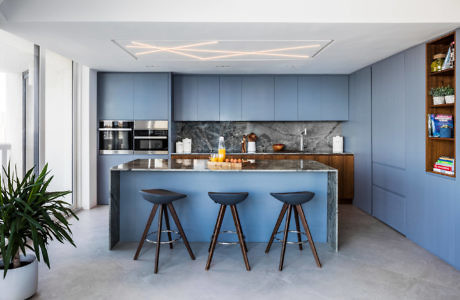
[0,254,38,300]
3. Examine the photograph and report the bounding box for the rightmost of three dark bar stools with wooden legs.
[265,192,321,271]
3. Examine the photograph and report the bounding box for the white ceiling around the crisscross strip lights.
[0,0,460,74]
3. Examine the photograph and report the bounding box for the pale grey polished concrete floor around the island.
[34,205,460,299]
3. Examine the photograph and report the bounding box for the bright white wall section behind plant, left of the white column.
[40,51,73,203]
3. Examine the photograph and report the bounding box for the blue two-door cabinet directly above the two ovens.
[97,73,171,120]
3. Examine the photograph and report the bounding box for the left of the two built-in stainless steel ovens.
[99,120,134,154]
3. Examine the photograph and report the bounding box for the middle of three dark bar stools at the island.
[205,192,251,271]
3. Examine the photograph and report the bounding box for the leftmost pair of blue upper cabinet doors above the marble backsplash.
[174,75,219,121]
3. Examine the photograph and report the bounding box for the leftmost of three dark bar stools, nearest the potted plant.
[134,189,195,273]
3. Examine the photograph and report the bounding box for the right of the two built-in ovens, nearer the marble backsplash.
[134,121,169,154]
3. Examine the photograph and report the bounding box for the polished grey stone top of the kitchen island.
[111,159,337,172]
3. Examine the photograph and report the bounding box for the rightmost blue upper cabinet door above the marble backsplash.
[320,75,348,121]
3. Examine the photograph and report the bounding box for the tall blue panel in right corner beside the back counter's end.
[342,67,372,214]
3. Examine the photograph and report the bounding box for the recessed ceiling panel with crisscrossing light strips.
[113,40,332,62]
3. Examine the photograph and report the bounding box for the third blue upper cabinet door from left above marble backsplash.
[219,76,242,121]
